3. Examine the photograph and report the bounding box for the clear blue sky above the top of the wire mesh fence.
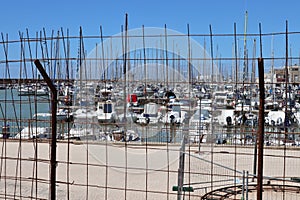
[0,0,300,78]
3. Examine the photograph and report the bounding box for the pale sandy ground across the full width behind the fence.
[0,142,300,200]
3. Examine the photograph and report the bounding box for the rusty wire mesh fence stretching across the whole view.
[0,21,300,199]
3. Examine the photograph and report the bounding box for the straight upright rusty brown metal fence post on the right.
[256,58,265,200]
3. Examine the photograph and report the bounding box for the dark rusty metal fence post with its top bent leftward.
[34,60,57,200]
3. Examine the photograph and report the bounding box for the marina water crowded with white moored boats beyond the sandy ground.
[0,79,300,146]
